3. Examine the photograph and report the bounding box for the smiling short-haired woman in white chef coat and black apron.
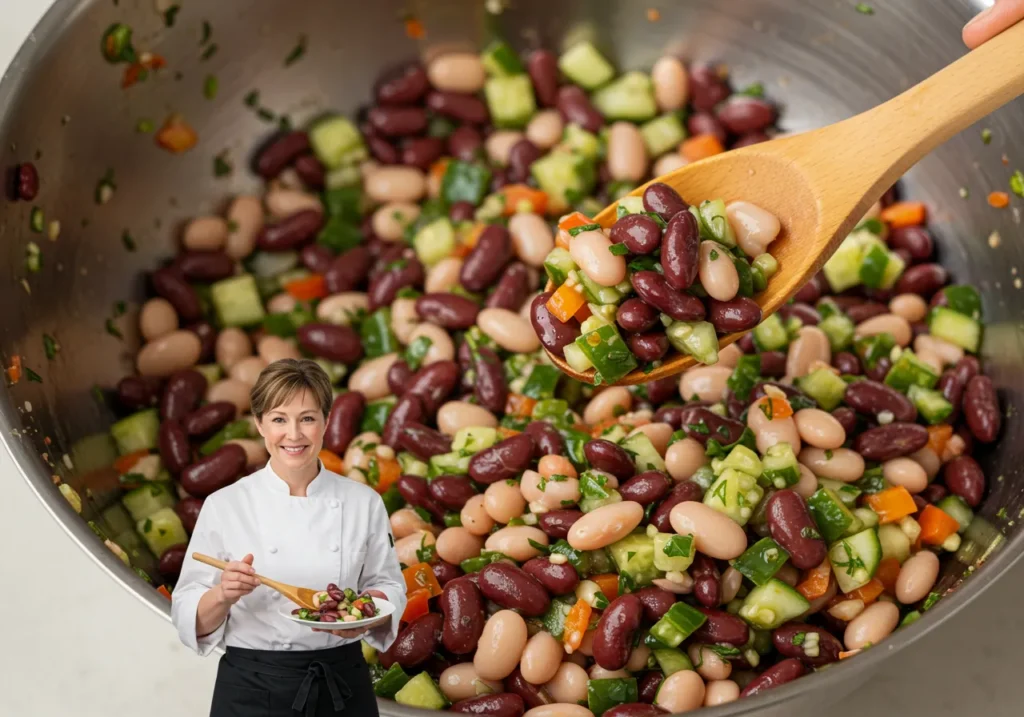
[171,359,406,717]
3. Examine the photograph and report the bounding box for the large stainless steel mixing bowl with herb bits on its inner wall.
[0,0,1024,715]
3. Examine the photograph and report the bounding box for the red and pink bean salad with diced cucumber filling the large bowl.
[101,32,1001,717]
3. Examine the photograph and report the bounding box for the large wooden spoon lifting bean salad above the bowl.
[547,23,1024,385]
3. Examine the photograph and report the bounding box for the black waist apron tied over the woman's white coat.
[210,642,380,717]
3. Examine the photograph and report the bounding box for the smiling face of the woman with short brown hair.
[256,390,327,472]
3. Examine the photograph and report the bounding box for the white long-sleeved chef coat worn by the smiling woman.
[171,463,406,656]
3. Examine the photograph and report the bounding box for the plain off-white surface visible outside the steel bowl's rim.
[0,0,1024,717]
